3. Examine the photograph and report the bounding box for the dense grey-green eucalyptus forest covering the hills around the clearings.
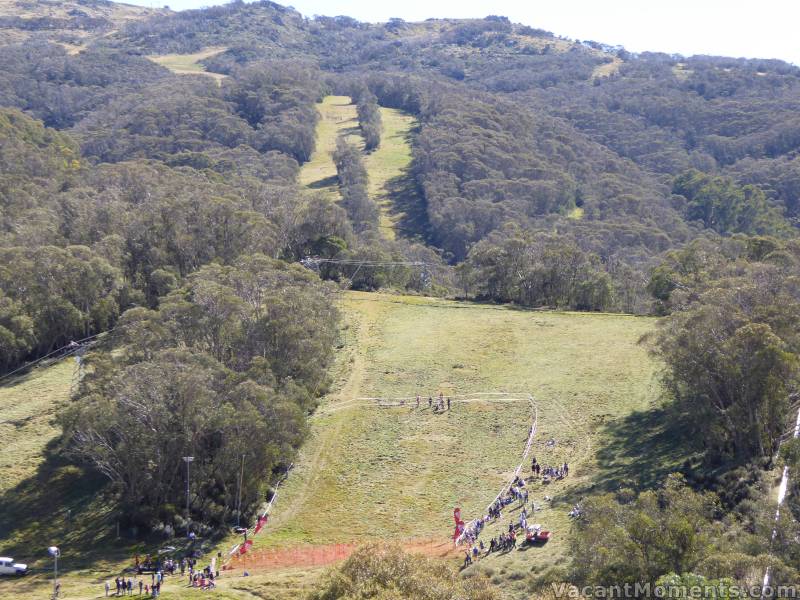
[0,0,800,582]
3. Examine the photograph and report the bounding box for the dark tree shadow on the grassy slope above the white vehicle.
[0,441,138,569]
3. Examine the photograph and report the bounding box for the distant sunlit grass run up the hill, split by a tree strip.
[299,96,416,239]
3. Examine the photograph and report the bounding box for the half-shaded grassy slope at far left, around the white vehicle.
[0,359,146,598]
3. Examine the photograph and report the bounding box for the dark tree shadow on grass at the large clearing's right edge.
[561,406,698,505]
